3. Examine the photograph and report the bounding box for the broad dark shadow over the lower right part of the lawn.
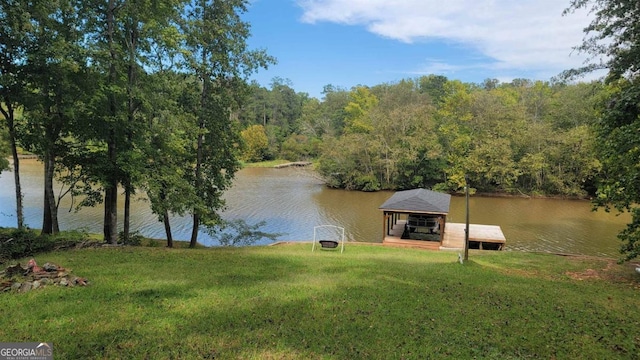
[172,262,640,359]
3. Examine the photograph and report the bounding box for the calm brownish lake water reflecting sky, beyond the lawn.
[0,160,630,257]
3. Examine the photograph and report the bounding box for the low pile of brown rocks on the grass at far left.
[0,259,89,292]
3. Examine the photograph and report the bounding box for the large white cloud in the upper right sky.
[298,0,590,77]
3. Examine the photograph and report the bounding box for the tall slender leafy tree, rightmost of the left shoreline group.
[181,0,274,247]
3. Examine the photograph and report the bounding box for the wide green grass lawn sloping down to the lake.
[0,244,640,359]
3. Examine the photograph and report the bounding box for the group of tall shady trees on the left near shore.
[0,0,274,246]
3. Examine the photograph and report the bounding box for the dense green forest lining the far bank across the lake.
[236,75,606,197]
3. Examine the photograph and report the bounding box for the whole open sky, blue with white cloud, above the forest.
[244,0,600,98]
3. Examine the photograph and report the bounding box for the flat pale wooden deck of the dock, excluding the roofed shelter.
[382,220,507,250]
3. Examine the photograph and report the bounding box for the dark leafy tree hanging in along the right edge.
[564,0,640,260]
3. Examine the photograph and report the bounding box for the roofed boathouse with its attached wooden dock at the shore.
[379,189,506,250]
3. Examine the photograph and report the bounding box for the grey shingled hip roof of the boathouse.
[379,189,451,214]
